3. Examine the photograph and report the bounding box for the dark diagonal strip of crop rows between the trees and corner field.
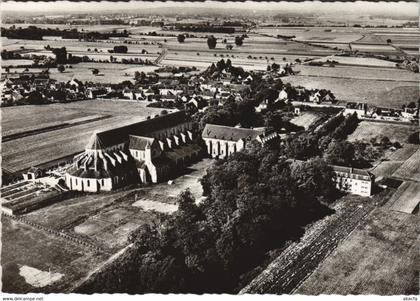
[240,190,393,294]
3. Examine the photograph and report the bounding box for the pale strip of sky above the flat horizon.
[1,1,418,16]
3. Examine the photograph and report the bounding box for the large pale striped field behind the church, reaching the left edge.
[1,100,160,171]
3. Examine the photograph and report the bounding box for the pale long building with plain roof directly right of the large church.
[202,124,279,158]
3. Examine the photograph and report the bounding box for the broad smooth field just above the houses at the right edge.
[282,76,419,109]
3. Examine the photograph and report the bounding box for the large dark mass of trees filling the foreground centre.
[80,144,335,293]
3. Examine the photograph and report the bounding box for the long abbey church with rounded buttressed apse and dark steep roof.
[65,111,201,192]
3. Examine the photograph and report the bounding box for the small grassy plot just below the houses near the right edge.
[347,121,416,143]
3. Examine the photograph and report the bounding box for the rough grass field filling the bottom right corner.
[296,208,420,295]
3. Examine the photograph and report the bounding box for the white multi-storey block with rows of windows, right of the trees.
[331,165,375,196]
